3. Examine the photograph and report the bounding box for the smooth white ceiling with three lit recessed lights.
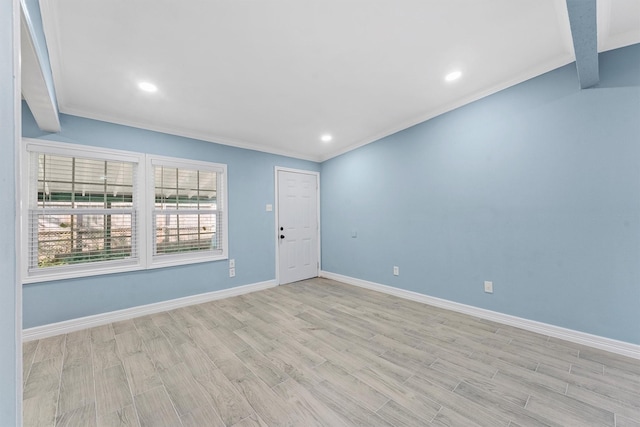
[40,0,640,161]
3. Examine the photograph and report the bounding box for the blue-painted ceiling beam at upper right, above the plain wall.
[567,0,600,89]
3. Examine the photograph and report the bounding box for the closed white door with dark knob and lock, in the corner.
[277,170,319,285]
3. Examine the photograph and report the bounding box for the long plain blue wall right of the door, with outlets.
[321,45,640,344]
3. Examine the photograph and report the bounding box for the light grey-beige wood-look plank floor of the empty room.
[24,279,640,427]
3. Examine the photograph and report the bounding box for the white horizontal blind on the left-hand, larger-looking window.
[28,148,139,272]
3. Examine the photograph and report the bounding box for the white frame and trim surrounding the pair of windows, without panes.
[18,138,229,284]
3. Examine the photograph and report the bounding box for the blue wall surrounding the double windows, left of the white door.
[23,107,320,328]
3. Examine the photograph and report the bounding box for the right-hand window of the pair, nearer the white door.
[149,157,226,264]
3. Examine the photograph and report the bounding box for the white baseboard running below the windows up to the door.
[22,280,278,342]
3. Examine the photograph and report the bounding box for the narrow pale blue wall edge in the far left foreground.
[0,1,22,426]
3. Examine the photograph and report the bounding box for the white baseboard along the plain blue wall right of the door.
[320,271,640,359]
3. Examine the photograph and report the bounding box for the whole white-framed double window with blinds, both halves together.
[23,140,227,283]
